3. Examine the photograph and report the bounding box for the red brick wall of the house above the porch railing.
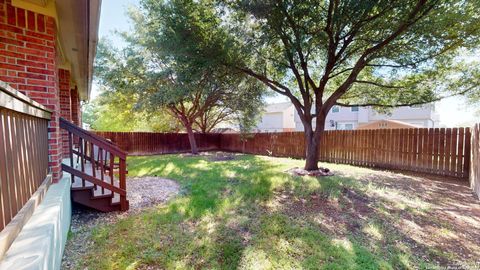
[0,0,61,180]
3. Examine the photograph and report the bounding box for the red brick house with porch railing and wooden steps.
[0,0,128,269]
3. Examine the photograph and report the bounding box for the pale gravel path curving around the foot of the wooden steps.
[62,176,180,269]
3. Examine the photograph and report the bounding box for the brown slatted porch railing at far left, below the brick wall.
[0,82,51,230]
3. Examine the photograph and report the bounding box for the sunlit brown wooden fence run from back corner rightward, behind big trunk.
[220,128,470,178]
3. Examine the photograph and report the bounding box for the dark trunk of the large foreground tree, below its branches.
[304,119,325,171]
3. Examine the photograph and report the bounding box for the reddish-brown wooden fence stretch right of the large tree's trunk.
[320,128,470,178]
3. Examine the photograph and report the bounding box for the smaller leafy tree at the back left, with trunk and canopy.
[97,1,264,154]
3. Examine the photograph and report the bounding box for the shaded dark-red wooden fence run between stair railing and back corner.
[94,131,220,155]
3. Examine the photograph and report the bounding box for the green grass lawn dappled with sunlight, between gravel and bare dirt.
[75,155,446,269]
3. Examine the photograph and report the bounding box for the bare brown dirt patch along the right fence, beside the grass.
[275,170,480,268]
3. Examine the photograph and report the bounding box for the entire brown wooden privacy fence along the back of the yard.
[97,128,471,178]
